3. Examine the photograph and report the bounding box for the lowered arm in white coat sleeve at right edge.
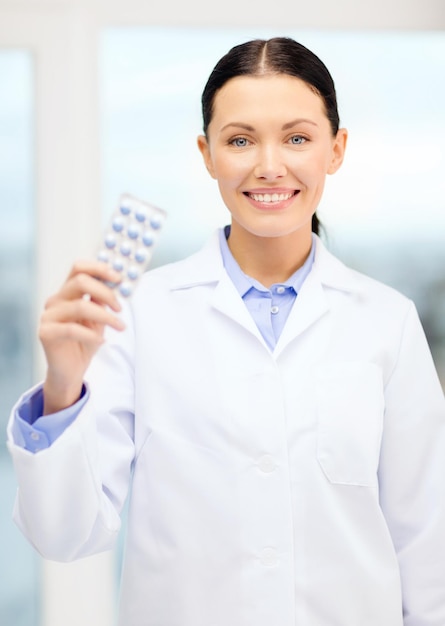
[379,300,445,626]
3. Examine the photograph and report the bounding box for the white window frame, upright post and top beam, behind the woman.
[0,0,445,626]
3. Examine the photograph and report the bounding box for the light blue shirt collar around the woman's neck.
[219,226,315,297]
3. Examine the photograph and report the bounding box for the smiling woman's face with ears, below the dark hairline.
[198,74,346,244]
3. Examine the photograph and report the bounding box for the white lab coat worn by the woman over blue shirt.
[9,232,445,626]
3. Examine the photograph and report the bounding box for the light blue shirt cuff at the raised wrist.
[13,385,90,452]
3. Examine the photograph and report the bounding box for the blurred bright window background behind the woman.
[0,0,445,626]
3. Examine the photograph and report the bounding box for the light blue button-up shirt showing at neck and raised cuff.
[13,226,315,452]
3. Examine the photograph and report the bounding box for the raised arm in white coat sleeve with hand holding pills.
[8,260,134,560]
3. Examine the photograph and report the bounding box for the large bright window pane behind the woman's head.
[101,28,445,272]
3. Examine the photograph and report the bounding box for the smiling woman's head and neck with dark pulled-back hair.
[198,38,347,284]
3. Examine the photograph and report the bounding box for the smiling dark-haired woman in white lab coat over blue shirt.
[9,38,445,626]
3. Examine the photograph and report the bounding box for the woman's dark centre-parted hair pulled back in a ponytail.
[201,37,340,234]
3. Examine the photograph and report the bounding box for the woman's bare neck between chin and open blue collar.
[228,223,312,288]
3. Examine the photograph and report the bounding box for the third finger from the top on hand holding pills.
[41,299,125,330]
